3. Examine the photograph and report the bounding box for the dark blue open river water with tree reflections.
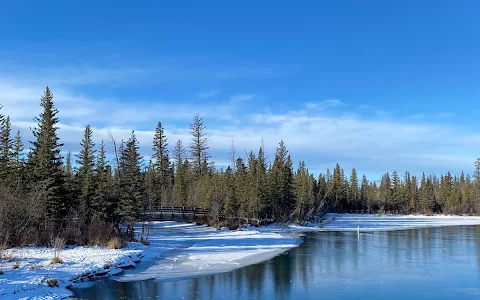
[71,226,480,299]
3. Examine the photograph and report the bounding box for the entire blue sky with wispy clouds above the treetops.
[0,1,480,179]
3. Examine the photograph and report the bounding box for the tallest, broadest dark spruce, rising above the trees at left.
[28,87,68,228]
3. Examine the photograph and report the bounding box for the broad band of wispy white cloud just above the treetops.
[0,66,480,177]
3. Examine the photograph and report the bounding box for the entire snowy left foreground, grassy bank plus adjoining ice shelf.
[0,222,302,300]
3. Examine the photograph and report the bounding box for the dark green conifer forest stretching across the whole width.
[0,87,480,246]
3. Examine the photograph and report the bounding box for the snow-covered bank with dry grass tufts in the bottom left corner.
[0,245,142,299]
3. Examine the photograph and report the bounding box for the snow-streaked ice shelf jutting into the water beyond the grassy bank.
[115,222,302,281]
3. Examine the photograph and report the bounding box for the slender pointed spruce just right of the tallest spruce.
[76,125,96,218]
